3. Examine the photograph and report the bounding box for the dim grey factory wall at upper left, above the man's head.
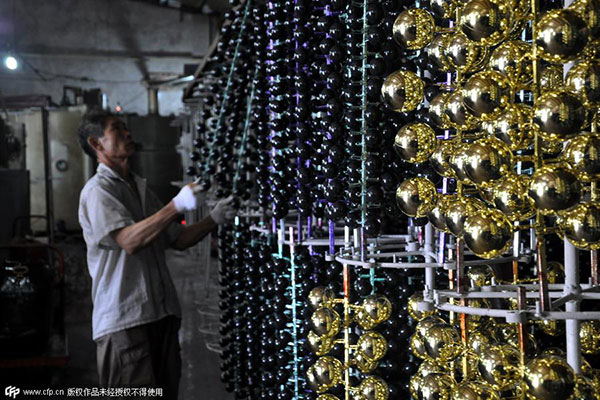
[0,0,212,115]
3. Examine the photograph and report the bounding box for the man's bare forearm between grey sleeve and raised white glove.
[111,201,179,254]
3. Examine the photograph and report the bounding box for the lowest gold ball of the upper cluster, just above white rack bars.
[463,208,513,258]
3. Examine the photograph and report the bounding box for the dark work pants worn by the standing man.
[96,316,181,400]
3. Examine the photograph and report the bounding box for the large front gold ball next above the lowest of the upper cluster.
[464,137,512,186]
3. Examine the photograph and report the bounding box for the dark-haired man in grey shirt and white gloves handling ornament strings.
[78,108,235,400]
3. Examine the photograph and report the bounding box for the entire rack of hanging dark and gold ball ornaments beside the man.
[182,0,600,400]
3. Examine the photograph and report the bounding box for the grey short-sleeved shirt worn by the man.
[79,164,181,339]
